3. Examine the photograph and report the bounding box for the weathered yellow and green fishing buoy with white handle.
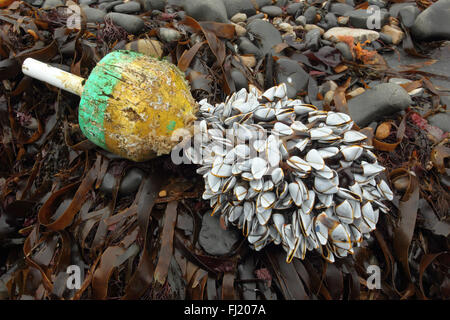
[22,50,196,161]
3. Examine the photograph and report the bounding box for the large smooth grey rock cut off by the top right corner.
[411,0,450,41]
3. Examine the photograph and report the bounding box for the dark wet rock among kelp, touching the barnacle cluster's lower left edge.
[198,211,239,256]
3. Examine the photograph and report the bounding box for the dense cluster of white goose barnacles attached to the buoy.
[186,84,393,262]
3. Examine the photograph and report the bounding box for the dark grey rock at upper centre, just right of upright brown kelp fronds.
[247,20,282,55]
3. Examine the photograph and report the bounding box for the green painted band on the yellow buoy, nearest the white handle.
[78,50,142,150]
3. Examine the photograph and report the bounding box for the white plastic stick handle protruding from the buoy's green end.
[22,58,84,96]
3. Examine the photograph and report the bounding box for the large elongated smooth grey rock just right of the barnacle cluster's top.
[348,83,412,127]
